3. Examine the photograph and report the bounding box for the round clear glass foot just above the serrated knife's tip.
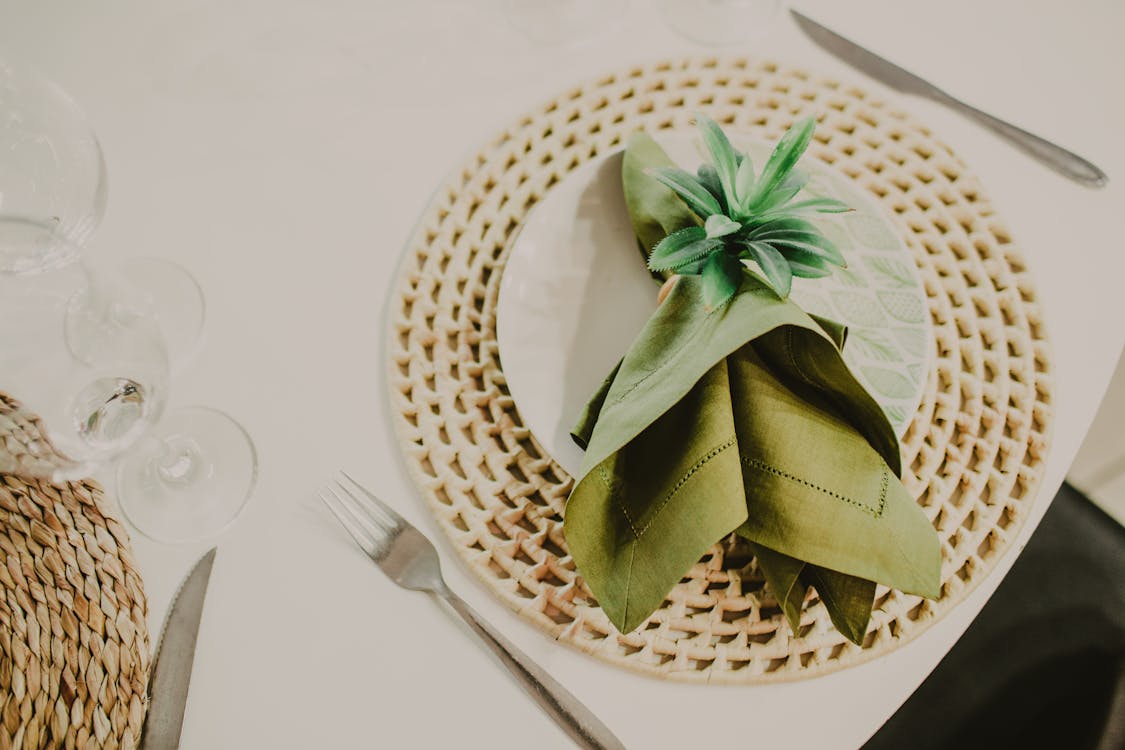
[117,407,258,544]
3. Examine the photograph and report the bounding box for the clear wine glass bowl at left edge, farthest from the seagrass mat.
[0,61,107,273]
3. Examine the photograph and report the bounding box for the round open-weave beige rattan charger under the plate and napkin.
[388,58,1052,683]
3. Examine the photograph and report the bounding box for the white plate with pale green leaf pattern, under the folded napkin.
[496,134,933,476]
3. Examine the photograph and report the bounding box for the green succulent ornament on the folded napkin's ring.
[647,115,852,308]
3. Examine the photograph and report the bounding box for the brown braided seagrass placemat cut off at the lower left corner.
[0,394,149,750]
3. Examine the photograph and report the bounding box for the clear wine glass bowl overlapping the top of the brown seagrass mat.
[0,251,169,474]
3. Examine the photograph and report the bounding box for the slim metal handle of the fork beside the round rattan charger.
[438,587,626,750]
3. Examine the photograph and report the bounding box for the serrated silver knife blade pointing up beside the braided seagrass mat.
[141,548,217,750]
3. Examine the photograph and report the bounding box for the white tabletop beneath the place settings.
[0,0,1125,750]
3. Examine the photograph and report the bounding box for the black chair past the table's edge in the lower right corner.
[864,485,1125,750]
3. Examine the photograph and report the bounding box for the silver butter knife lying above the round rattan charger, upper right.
[789,8,1109,188]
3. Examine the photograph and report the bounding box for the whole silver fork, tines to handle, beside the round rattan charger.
[320,471,624,750]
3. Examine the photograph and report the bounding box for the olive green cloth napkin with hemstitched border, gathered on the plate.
[565,136,941,643]
